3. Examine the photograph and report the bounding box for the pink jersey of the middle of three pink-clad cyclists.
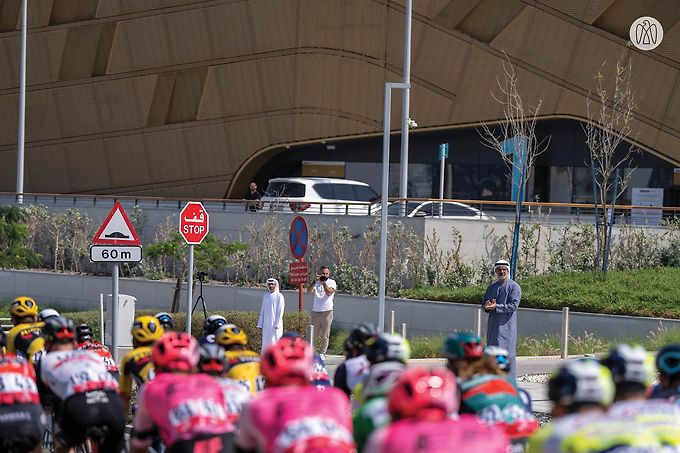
[236,385,354,453]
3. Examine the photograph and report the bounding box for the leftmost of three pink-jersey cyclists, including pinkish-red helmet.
[130,332,234,453]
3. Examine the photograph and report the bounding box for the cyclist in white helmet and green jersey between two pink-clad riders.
[352,362,406,451]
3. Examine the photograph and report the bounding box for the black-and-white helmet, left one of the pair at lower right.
[548,358,614,407]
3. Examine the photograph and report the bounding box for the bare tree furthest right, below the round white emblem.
[583,54,639,273]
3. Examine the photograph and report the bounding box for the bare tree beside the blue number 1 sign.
[480,55,550,278]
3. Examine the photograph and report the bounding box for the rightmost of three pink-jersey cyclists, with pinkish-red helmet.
[363,368,509,453]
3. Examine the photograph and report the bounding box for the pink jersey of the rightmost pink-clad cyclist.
[364,415,508,453]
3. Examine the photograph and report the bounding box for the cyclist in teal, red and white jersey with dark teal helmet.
[444,331,538,451]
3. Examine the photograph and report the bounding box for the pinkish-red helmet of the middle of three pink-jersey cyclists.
[260,337,314,386]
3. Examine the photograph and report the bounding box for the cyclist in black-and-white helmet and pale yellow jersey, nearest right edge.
[601,344,680,451]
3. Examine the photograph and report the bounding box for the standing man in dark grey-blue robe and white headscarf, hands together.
[482,260,522,378]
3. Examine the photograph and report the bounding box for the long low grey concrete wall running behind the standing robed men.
[0,271,680,338]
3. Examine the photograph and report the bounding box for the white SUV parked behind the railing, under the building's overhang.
[261,177,380,215]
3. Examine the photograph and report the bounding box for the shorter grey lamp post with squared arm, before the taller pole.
[378,82,409,332]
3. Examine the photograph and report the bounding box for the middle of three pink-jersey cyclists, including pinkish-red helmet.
[236,337,356,453]
